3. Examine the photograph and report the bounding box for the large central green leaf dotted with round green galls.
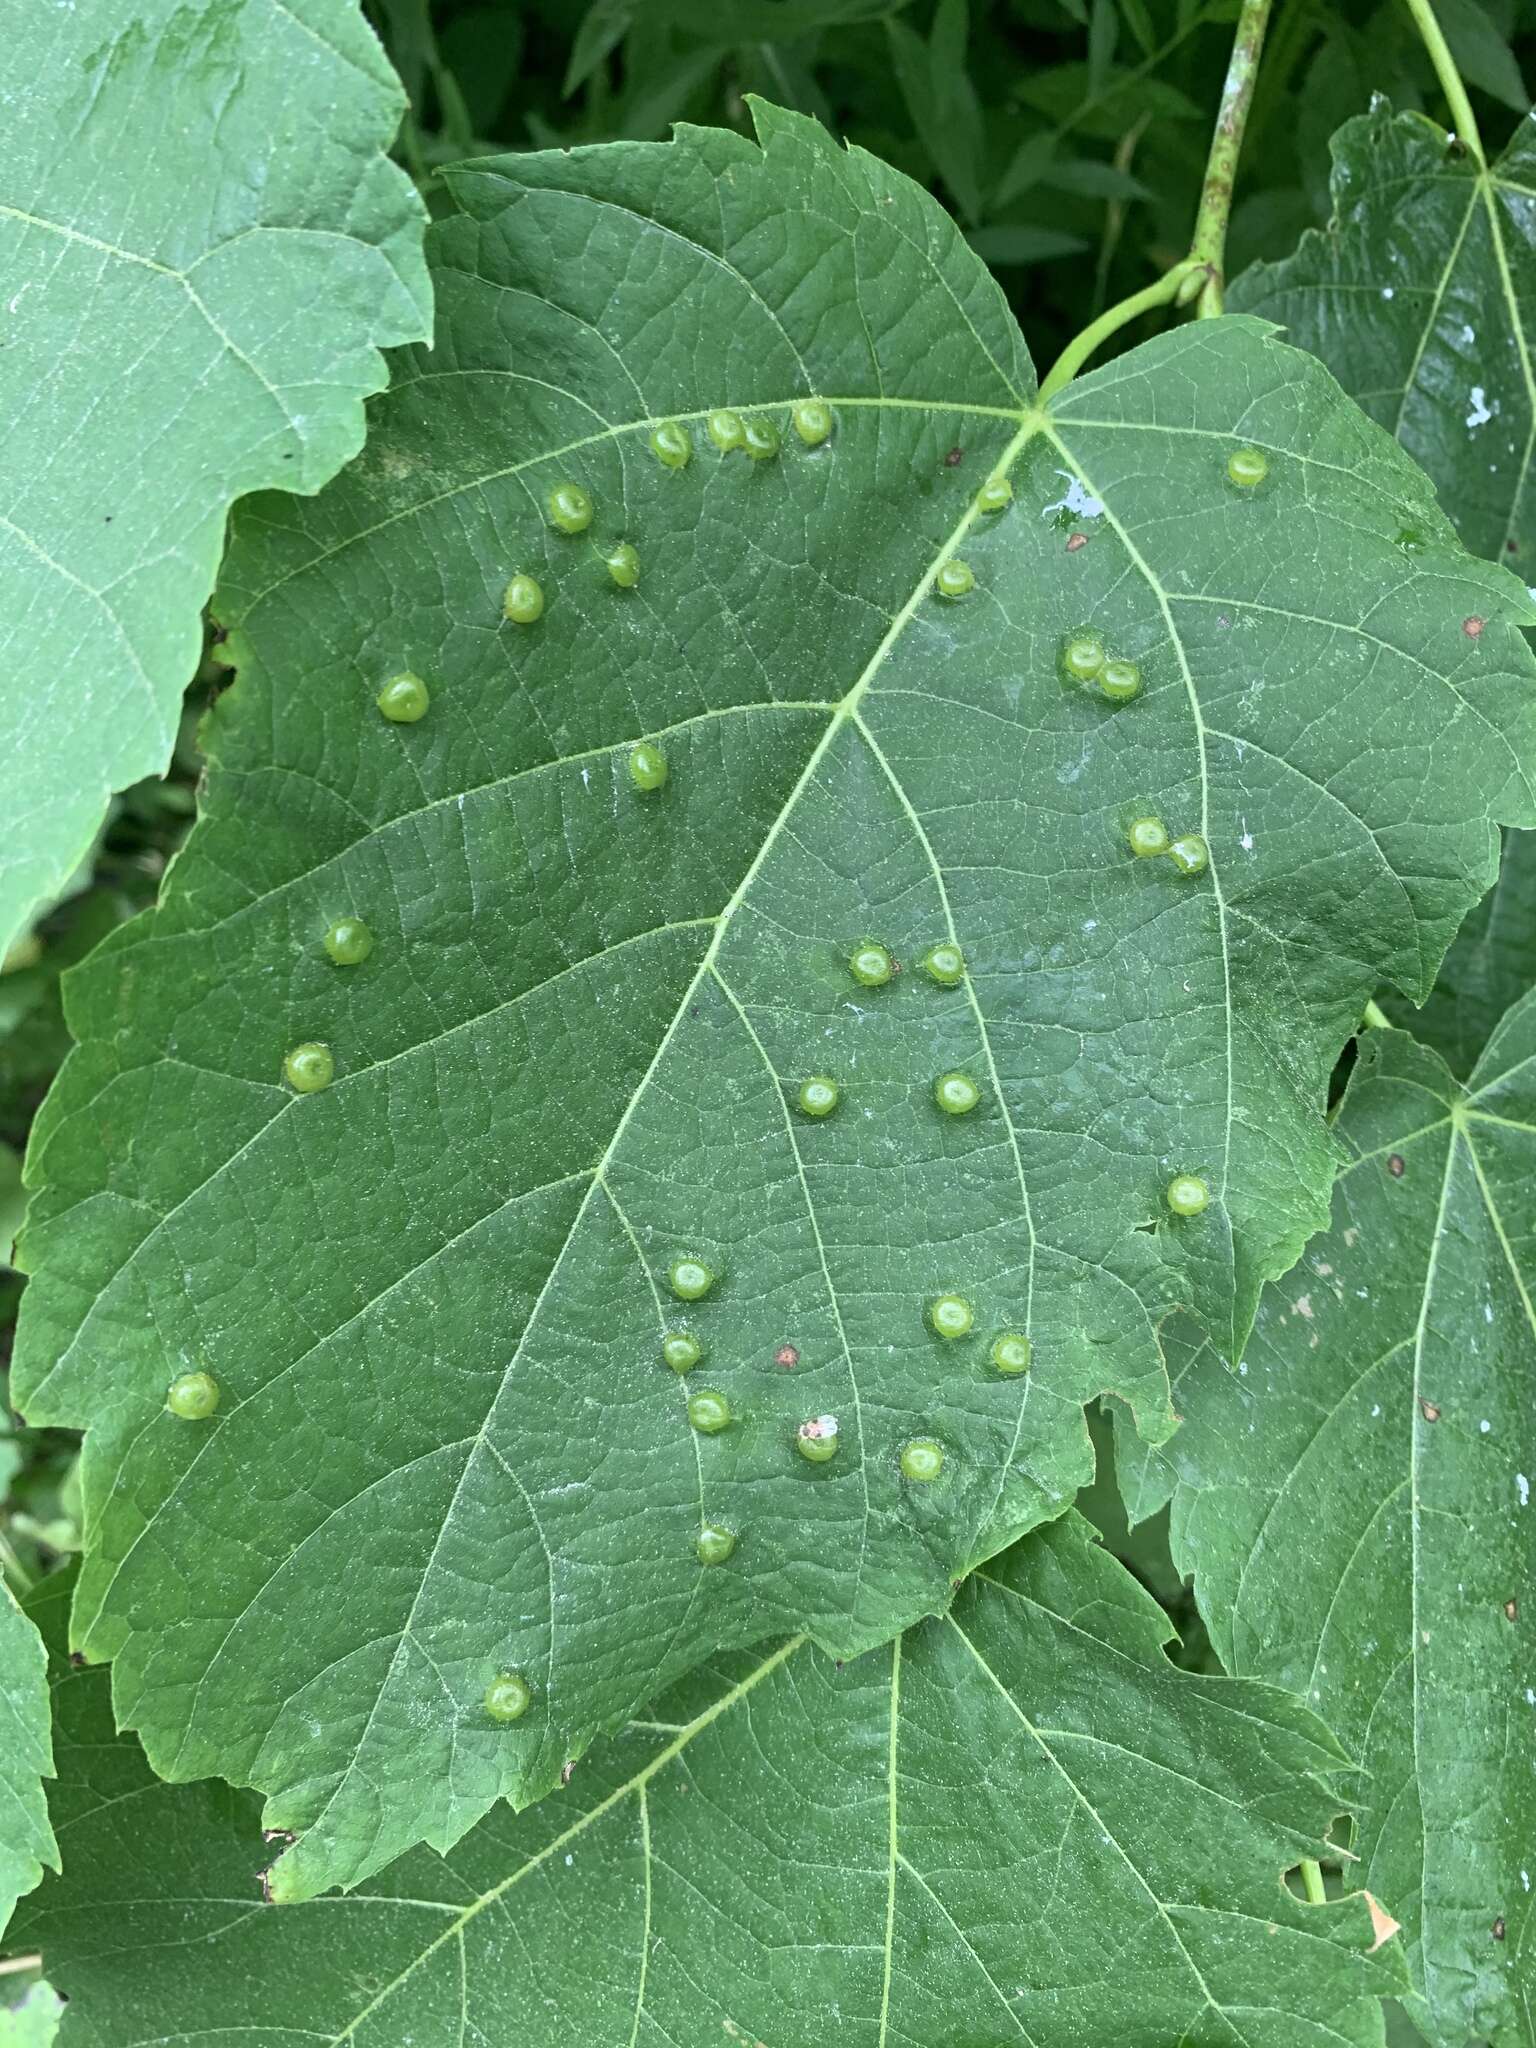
[16,113,1536,1896]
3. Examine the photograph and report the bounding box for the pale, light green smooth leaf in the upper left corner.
[0,0,428,954]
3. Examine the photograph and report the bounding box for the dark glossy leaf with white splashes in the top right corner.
[1229,100,1536,582]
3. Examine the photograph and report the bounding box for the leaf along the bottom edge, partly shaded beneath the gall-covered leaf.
[18,1518,1403,2048]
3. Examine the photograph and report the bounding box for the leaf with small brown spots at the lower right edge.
[1130,1024,1536,2048]
